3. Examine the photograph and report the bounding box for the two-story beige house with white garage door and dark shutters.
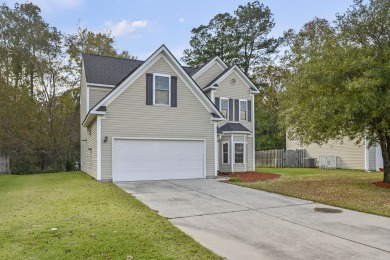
[80,45,258,181]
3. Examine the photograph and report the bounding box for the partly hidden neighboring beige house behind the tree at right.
[286,138,383,171]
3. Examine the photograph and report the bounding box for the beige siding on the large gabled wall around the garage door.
[102,54,215,180]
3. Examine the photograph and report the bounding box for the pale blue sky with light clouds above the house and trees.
[5,0,353,59]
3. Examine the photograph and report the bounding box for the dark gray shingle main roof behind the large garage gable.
[82,53,198,86]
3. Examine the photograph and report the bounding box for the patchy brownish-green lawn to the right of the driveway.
[239,168,390,217]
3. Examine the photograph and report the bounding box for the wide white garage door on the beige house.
[113,139,205,181]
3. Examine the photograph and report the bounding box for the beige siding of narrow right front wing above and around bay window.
[215,71,254,171]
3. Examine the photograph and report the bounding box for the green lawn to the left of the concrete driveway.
[0,172,219,259]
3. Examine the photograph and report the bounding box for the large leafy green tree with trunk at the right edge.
[281,0,390,183]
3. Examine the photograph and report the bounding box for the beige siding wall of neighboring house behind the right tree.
[286,138,365,170]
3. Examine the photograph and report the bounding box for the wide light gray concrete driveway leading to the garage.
[116,179,390,259]
